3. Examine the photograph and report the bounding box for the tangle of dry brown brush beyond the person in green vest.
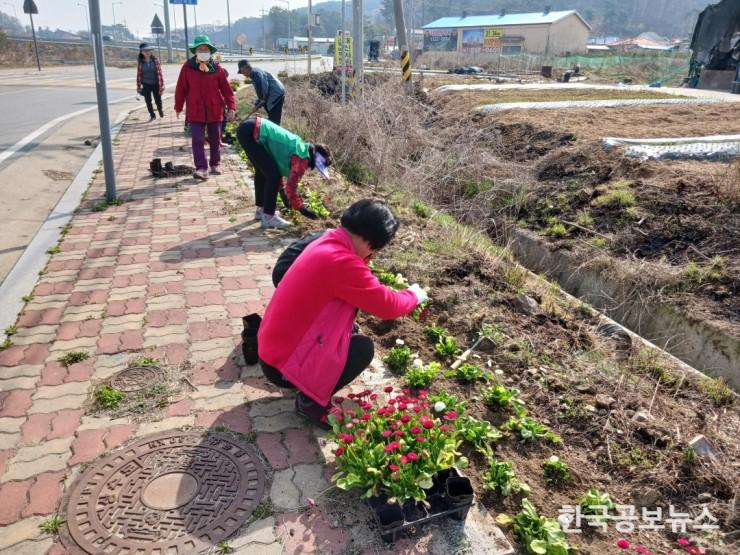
[287,75,527,239]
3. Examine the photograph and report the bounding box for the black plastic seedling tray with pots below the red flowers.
[368,468,475,542]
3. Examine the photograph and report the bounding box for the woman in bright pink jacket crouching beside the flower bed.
[257,200,427,426]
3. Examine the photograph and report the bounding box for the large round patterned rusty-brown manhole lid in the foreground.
[67,432,265,555]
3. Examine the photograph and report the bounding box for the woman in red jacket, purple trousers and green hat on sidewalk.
[175,35,236,181]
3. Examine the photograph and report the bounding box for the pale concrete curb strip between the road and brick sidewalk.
[0,106,136,339]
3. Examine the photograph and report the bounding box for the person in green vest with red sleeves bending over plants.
[236,117,331,229]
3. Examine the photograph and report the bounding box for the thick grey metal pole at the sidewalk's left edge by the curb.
[90,0,116,202]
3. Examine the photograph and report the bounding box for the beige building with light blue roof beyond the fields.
[423,9,591,56]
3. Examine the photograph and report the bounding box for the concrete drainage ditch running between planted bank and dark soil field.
[510,230,740,391]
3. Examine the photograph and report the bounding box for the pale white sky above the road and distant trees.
[0,0,317,36]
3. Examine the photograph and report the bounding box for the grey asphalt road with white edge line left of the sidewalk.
[0,59,326,282]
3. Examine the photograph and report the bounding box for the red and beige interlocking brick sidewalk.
[0,101,512,555]
